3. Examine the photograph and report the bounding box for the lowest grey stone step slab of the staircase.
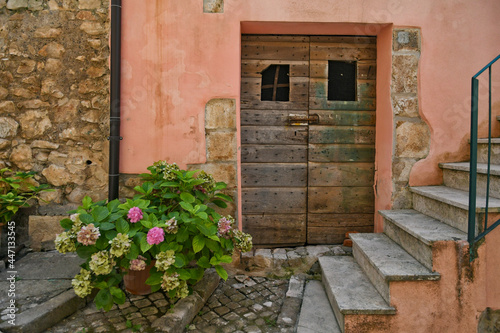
[318,256,396,332]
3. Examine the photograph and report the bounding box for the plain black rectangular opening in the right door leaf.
[328,60,356,101]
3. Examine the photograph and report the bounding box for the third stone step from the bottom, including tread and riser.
[379,209,467,271]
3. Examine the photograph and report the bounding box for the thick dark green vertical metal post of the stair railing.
[467,77,479,261]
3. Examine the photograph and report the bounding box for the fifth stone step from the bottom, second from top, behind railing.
[439,162,500,198]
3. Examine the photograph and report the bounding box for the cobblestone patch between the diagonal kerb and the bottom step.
[185,275,295,333]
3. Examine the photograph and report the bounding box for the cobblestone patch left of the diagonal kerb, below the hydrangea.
[46,291,173,333]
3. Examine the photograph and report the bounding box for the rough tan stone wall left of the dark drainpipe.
[0,0,109,211]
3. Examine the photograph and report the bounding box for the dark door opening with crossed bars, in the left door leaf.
[260,65,290,102]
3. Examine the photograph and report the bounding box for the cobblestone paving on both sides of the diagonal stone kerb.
[46,275,295,333]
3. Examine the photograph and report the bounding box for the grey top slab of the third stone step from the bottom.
[379,209,467,246]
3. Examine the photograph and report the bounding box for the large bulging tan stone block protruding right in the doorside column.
[395,121,430,158]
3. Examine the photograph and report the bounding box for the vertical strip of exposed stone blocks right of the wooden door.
[391,29,430,209]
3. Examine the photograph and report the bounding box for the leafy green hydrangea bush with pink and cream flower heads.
[55,161,252,311]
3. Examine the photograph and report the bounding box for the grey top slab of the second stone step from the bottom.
[351,233,441,282]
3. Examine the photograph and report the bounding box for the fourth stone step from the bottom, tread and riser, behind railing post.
[410,186,500,233]
